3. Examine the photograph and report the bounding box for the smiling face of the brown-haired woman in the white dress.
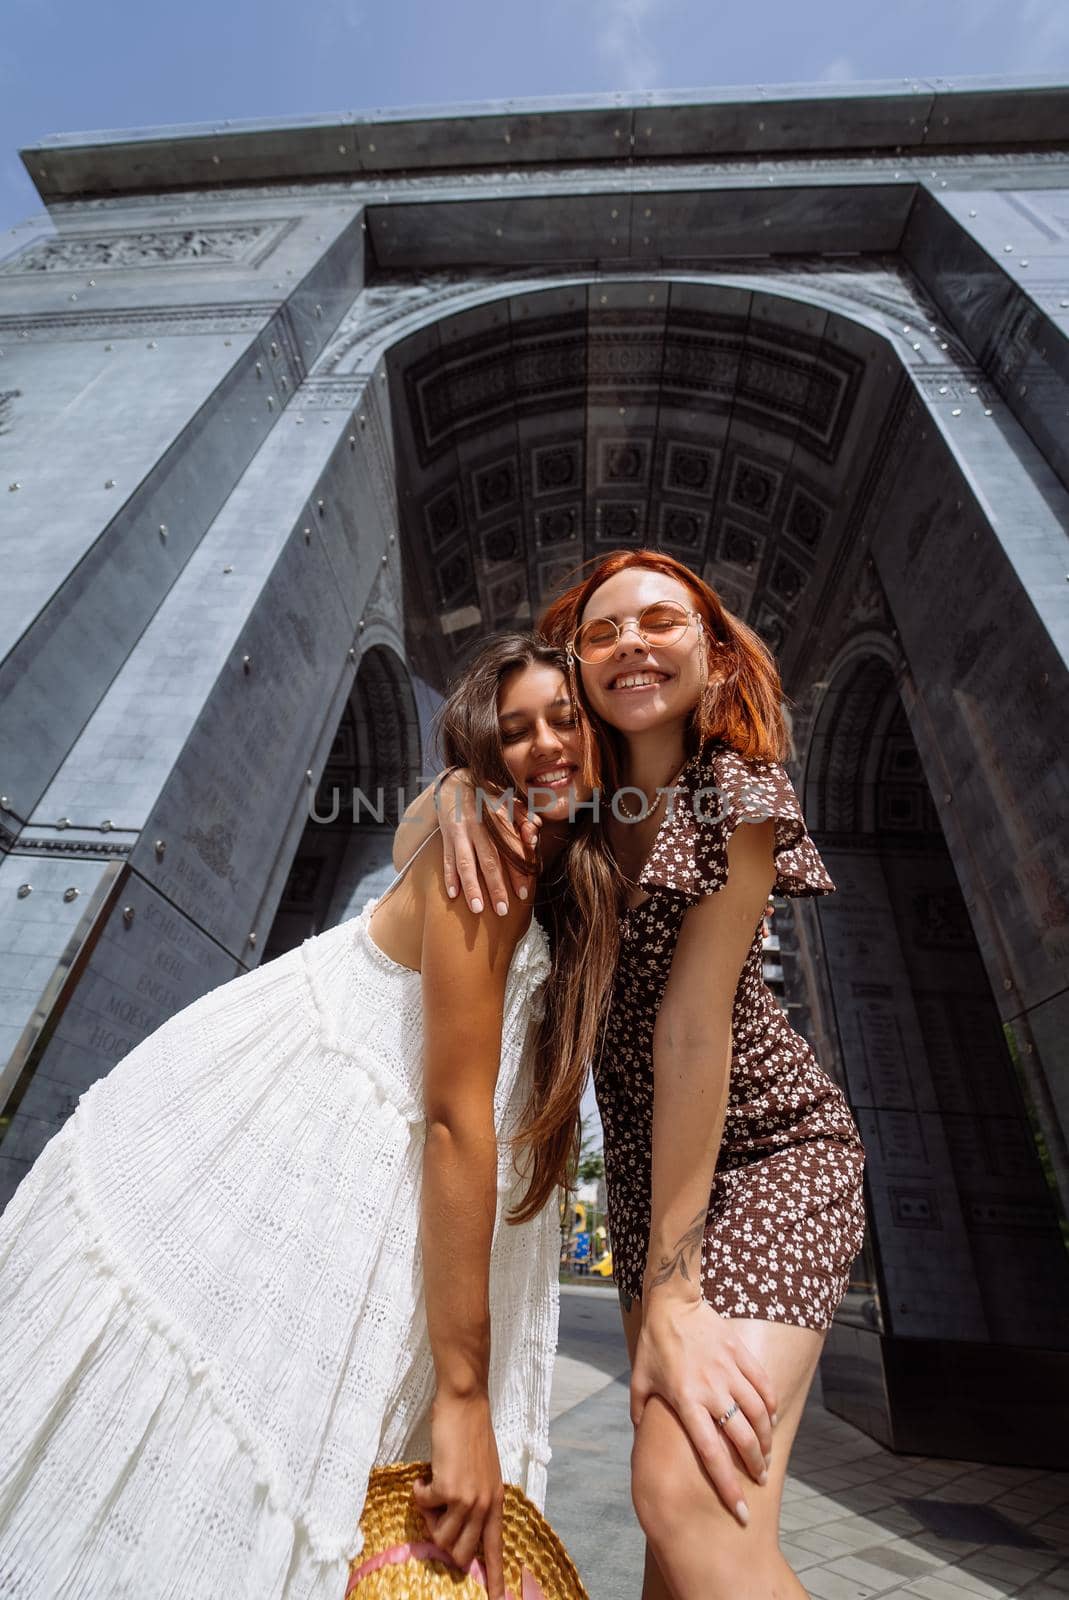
[498,664,591,822]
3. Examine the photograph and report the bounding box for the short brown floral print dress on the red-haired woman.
[594,741,864,1330]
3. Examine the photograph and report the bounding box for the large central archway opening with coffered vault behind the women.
[386,278,1069,1461]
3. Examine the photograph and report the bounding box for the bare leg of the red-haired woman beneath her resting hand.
[624,1302,824,1600]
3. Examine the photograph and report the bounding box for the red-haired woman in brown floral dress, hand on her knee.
[419,550,864,1600]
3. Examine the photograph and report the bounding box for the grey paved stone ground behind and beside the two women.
[546,1286,1069,1600]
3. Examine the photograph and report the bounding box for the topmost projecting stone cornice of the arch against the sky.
[21,77,1069,202]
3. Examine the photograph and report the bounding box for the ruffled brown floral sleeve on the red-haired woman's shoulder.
[640,742,835,904]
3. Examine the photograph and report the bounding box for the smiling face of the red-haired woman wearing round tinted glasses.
[578,566,706,734]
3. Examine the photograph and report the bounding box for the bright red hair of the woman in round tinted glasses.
[538,550,791,784]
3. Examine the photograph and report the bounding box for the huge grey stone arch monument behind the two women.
[0,80,1069,1464]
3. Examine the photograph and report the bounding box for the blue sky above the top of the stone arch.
[0,0,1069,229]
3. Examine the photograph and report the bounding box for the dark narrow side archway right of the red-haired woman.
[805,651,1069,1454]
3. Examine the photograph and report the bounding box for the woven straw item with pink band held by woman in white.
[346,1461,589,1600]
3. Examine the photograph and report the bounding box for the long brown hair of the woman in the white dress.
[435,634,618,1222]
